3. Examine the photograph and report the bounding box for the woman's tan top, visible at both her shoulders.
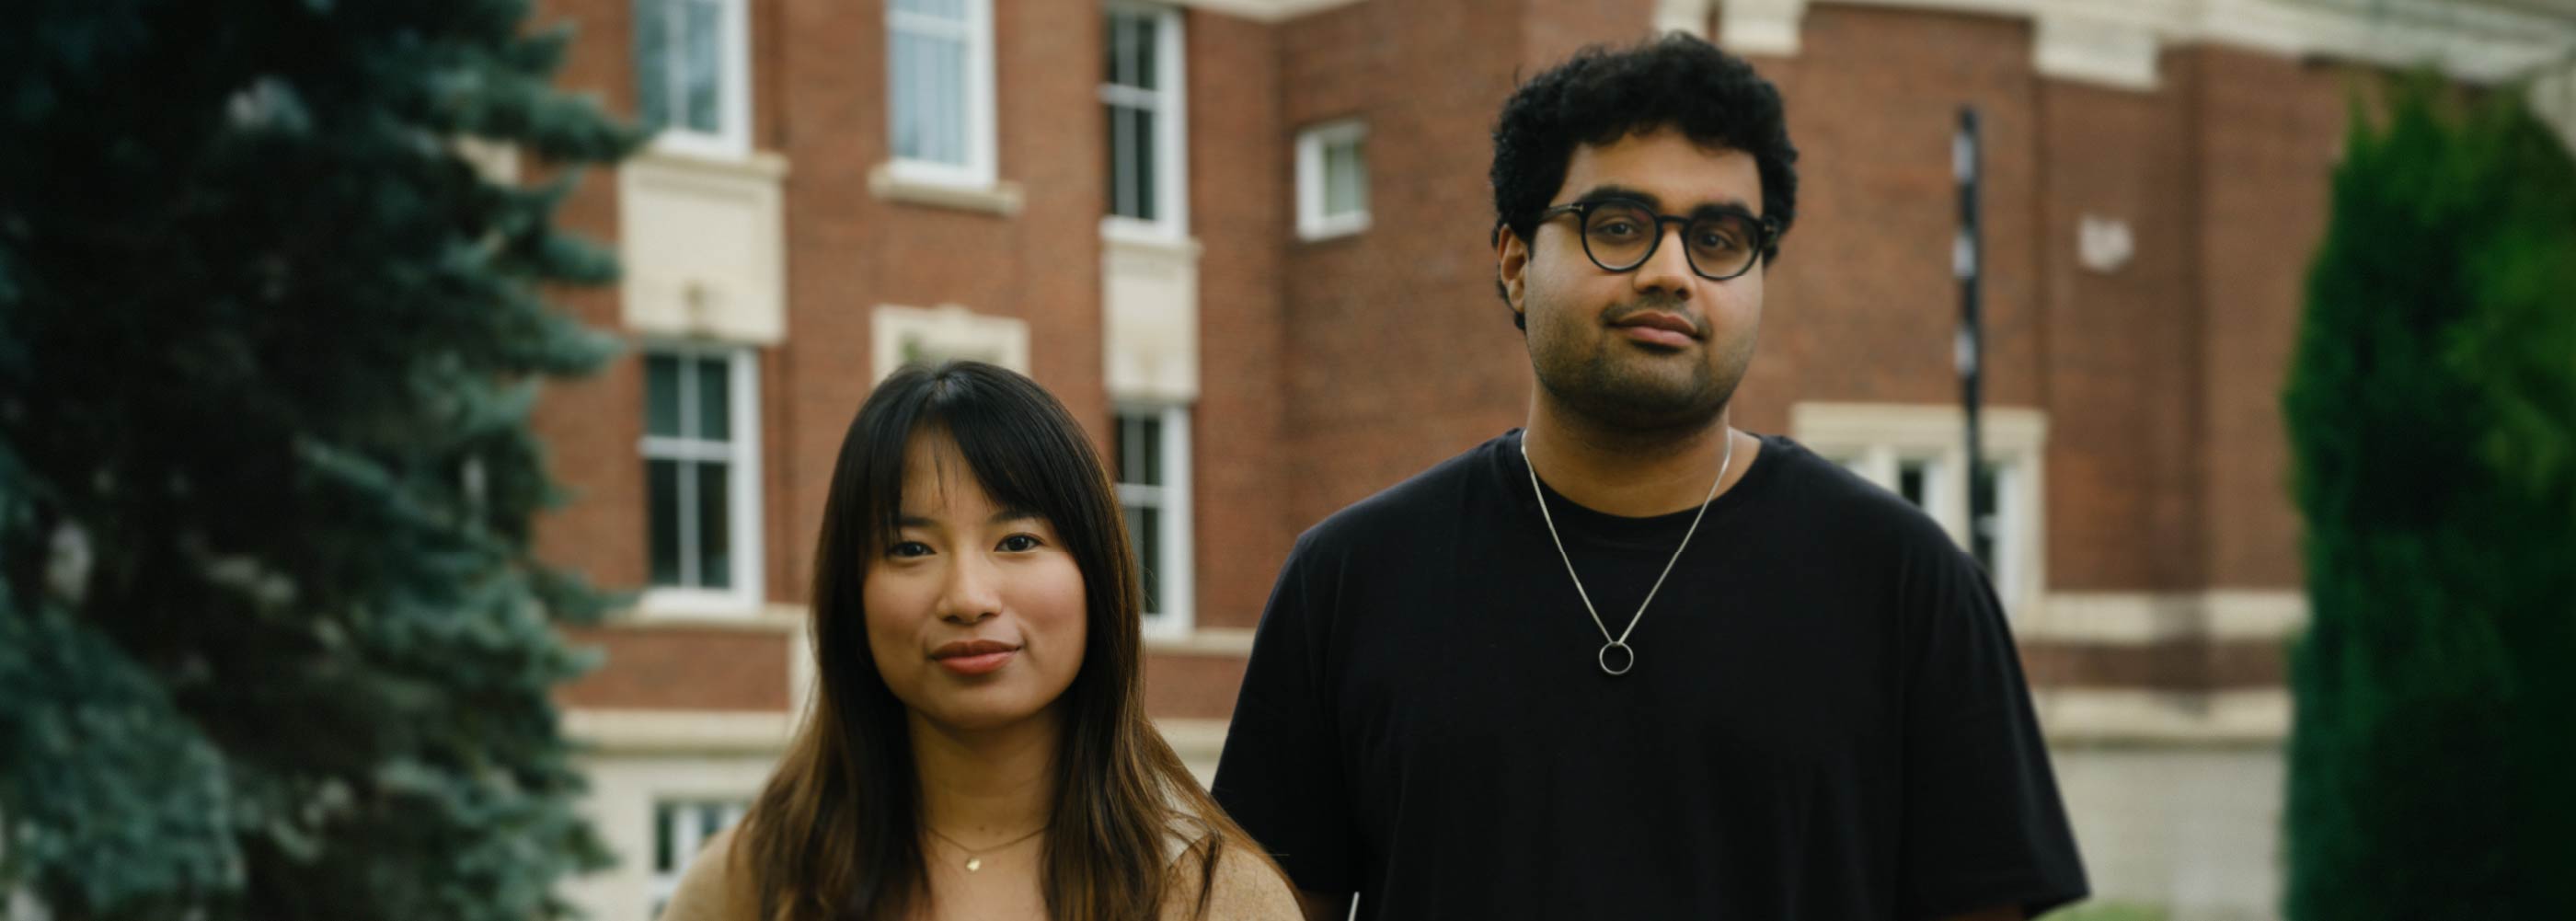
[662,828,1306,921]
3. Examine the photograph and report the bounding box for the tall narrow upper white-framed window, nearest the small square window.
[1100,0,1188,236]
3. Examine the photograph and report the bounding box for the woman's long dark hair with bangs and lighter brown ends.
[727,363,1268,921]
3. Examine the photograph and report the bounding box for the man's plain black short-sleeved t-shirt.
[1216,432,2084,921]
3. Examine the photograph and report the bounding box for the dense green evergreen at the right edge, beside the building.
[2283,74,2576,921]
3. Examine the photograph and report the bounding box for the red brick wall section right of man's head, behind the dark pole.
[1733,7,2041,432]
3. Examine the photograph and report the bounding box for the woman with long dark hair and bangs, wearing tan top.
[662,363,1298,921]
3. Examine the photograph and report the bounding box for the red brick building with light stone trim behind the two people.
[523,0,2576,918]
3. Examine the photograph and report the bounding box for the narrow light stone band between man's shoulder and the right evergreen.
[2012,589,2308,646]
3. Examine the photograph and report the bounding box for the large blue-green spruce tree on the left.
[0,0,637,921]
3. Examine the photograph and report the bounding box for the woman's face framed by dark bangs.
[860,432,1087,731]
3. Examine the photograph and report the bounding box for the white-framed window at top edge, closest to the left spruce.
[634,0,753,157]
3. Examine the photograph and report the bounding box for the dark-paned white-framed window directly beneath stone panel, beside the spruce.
[641,345,763,615]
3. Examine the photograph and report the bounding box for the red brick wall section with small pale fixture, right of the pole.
[2042,72,2202,592]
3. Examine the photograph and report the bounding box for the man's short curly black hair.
[1491,33,1798,309]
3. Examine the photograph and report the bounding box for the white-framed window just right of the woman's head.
[1118,404,1195,636]
